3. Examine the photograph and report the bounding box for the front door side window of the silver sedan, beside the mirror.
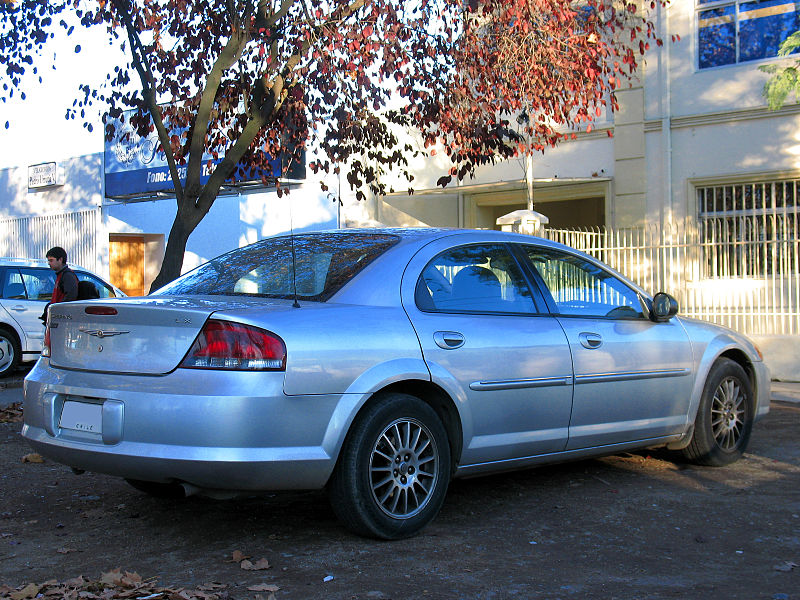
[524,246,645,319]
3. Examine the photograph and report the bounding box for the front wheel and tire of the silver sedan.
[682,358,753,467]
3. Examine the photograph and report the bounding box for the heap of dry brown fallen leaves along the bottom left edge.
[0,569,238,600]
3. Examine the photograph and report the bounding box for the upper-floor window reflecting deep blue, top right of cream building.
[695,0,800,69]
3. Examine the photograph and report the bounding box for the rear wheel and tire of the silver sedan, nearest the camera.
[328,393,450,540]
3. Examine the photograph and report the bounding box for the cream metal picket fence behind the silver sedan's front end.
[543,223,800,335]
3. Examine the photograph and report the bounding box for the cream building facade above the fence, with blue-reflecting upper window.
[346,0,800,228]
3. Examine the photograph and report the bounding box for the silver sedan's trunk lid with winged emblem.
[50,296,292,375]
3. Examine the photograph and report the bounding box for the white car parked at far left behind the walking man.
[0,258,125,377]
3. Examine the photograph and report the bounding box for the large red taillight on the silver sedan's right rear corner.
[180,320,286,371]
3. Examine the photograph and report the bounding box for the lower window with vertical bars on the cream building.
[697,179,800,278]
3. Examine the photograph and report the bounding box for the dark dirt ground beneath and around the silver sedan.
[0,390,800,600]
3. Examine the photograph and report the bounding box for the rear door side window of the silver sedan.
[416,244,536,313]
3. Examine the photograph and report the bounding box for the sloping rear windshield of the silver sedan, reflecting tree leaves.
[153,232,400,302]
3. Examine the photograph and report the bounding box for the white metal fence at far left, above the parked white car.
[0,208,100,271]
